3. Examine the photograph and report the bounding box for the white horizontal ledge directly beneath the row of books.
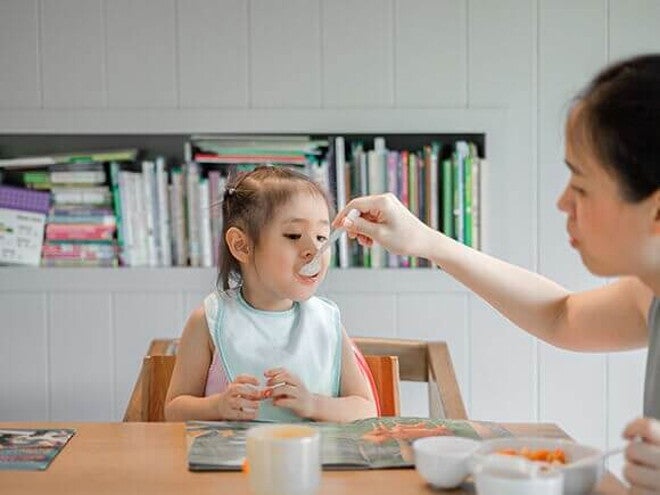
[0,267,467,294]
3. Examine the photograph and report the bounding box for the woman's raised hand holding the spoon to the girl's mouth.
[332,193,433,257]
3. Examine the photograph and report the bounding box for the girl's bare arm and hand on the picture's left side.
[165,307,260,421]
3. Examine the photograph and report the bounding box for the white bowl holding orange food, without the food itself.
[470,437,604,495]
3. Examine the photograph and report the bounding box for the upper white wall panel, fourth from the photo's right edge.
[394,0,467,108]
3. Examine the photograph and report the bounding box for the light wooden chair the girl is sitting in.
[124,337,467,421]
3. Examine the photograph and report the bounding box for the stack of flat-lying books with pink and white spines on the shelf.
[42,163,117,267]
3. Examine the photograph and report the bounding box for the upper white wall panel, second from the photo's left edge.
[41,0,106,108]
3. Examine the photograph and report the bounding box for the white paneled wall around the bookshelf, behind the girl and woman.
[0,0,660,480]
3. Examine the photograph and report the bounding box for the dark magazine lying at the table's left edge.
[0,428,76,471]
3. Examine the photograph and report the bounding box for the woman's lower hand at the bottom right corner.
[623,418,660,495]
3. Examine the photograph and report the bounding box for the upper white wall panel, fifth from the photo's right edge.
[321,0,394,108]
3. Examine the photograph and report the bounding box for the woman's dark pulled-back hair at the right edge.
[577,54,660,203]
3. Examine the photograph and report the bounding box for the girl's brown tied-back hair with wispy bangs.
[216,166,334,290]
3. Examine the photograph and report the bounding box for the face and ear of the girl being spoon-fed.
[242,192,330,310]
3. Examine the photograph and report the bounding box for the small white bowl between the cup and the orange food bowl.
[413,437,480,489]
